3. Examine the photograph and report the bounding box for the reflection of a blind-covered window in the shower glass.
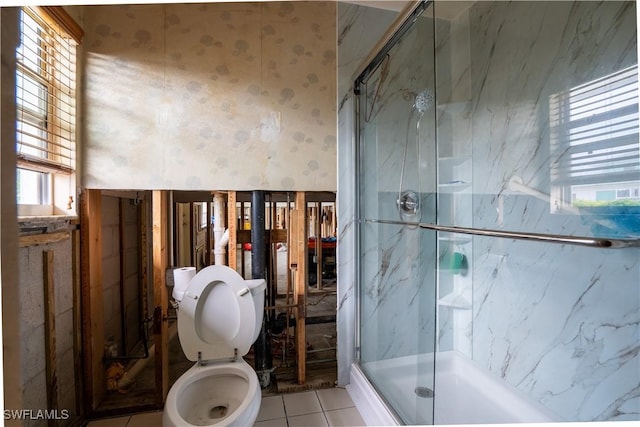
[550,66,640,211]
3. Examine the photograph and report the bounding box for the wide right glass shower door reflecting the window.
[435,1,640,424]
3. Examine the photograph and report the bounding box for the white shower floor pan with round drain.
[358,351,562,424]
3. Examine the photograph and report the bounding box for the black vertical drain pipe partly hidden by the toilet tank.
[251,190,273,388]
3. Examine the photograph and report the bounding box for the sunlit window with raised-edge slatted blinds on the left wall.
[16,7,82,215]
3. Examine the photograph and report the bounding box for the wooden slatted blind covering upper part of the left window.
[16,7,76,173]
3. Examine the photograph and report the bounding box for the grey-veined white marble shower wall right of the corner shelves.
[438,2,640,421]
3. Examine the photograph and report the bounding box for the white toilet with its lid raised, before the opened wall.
[162,265,266,427]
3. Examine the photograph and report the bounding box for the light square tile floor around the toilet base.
[87,387,365,427]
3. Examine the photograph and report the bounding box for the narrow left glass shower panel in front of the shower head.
[356,2,436,424]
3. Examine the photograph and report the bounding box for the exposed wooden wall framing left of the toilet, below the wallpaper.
[79,190,169,417]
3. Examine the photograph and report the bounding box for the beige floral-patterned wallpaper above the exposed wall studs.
[82,1,337,191]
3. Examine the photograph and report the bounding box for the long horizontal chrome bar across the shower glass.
[364,219,640,249]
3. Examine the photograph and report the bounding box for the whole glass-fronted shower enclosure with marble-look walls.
[353,1,640,424]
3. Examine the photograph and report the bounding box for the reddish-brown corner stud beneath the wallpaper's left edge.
[80,190,107,415]
